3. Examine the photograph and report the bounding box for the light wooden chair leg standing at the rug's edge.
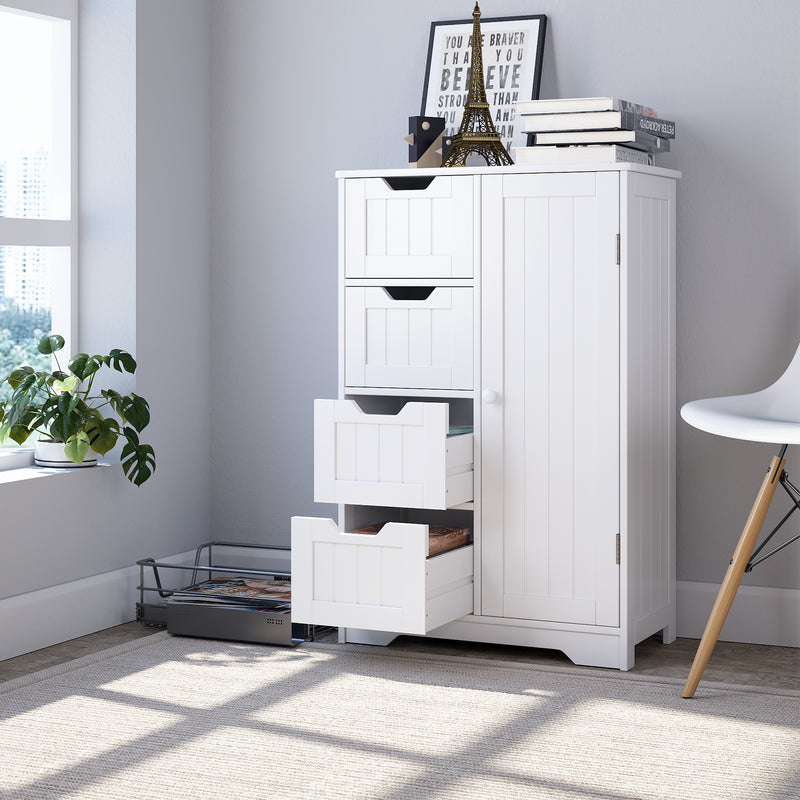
[683,451,784,697]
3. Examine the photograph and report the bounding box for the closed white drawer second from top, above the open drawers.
[344,286,473,389]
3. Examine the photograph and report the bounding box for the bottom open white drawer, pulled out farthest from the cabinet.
[292,517,473,634]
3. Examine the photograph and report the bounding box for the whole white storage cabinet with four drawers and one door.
[292,164,679,669]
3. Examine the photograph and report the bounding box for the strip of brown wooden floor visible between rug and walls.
[0,622,800,690]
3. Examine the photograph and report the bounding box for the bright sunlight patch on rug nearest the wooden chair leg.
[492,698,800,798]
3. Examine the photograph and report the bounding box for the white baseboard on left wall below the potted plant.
[0,551,194,661]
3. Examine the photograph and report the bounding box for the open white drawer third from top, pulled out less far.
[314,400,473,509]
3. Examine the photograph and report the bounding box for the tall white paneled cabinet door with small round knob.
[480,172,620,626]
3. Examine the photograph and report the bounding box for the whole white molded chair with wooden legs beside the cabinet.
[681,347,800,697]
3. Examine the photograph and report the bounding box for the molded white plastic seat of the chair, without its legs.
[681,347,800,444]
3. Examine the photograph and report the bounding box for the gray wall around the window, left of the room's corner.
[0,0,210,600]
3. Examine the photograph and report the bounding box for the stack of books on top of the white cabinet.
[514,97,675,164]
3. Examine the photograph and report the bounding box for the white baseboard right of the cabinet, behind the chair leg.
[676,581,800,647]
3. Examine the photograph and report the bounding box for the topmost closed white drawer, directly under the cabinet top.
[344,175,474,278]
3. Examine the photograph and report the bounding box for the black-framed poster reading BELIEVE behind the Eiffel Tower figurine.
[422,14,547,153]
